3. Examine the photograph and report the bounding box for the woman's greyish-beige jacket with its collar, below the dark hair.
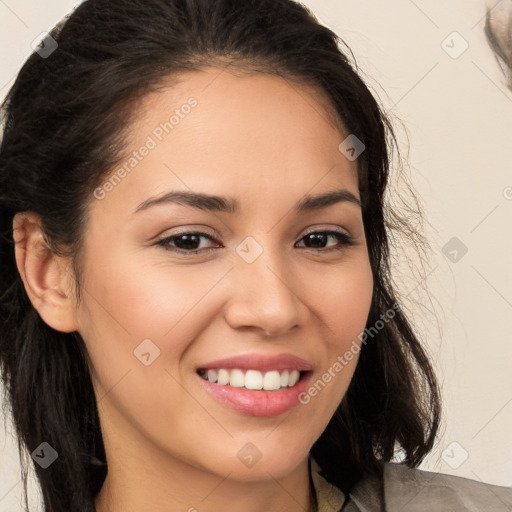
[309,457,512,512]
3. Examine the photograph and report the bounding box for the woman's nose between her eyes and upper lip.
[225,243,307,336]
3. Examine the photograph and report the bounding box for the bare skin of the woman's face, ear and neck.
[14,68,373,512]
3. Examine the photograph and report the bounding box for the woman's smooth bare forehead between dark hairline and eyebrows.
[92,68,357,214]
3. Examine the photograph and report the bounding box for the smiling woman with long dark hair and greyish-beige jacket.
[0,0,512,512]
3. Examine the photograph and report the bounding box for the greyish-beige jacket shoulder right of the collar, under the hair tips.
[383,463,512,512]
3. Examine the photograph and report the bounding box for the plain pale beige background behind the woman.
[0,0,512,512]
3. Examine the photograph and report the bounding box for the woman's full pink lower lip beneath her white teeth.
[197,372,311,417]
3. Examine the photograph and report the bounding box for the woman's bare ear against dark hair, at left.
[13,212,78,332]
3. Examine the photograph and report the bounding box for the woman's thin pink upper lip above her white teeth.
[196,354,313,372]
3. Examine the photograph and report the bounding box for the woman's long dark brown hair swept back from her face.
[0,0,440,512]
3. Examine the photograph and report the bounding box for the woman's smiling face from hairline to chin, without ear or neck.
[77,68,373,481]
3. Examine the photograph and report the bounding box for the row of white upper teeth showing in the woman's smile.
[200,368,300,391]
